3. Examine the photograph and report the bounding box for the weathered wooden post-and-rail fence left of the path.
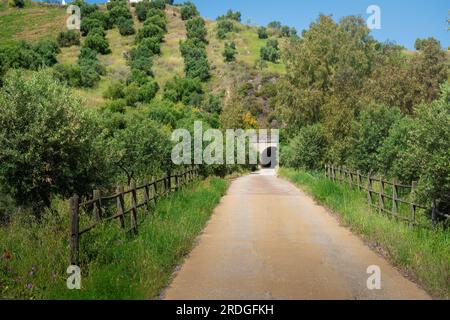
[70,167,199,265]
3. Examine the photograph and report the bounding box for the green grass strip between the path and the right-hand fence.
[279,168,450,299]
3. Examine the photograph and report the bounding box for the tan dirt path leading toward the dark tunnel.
[164,174,430,300]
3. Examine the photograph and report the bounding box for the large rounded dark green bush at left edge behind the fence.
[0,71,107,210]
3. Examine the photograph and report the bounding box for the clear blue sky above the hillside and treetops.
[176,0,450,49]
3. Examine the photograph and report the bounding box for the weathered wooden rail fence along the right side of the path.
[325,165,450,226]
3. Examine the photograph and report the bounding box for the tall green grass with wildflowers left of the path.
[0,178,228,300]
